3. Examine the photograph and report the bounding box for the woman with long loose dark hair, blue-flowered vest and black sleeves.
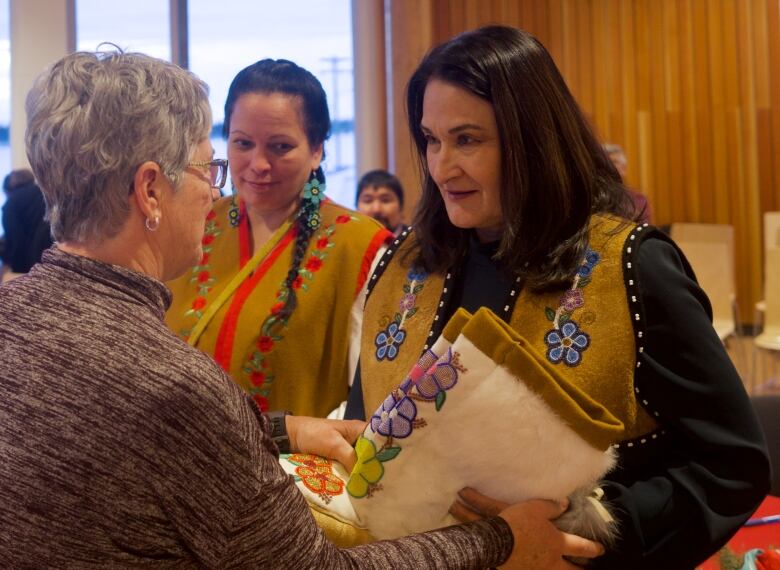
[347,26,769,569]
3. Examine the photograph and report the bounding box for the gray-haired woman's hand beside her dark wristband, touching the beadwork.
[285,416,366,471]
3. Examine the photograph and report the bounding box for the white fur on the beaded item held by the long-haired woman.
[353,335,615,539]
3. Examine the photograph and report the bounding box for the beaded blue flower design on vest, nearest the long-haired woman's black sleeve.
[544,248,601,366]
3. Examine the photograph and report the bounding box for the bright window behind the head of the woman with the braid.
[190,0,355,207]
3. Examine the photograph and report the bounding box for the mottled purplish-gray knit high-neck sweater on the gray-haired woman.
[0,249,512,568]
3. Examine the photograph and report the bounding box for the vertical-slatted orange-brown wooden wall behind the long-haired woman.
[385,0,780,322]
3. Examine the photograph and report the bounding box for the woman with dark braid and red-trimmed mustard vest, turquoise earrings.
[167,59,390,417]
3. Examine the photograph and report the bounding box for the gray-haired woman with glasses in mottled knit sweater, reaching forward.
[0,53,600,568]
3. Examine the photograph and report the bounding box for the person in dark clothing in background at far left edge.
[0,168,52,281]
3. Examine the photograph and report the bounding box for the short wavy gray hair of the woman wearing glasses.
[25,51,211,242]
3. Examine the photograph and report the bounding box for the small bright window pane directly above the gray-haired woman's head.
[76,0,171,61]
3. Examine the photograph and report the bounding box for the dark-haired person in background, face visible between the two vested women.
[355,170,408,236]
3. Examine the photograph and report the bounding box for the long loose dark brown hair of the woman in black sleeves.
[407,26,635,289]
